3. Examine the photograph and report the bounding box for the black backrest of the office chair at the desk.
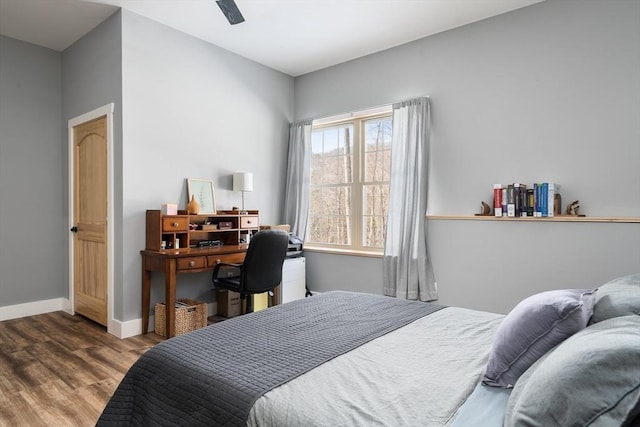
[241,229,289,294]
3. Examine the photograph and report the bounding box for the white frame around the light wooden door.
[67,102,116,334]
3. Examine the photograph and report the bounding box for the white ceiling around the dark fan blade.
[0,0,543,76]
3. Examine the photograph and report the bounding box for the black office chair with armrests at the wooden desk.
[211,229,289,313]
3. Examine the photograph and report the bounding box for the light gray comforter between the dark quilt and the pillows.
[247,307,507,427]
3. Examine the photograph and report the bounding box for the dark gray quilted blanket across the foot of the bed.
[97,292,443,426]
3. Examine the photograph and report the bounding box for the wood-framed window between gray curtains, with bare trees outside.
[307,111,392,252]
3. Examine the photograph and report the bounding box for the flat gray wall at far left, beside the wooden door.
[0,36,68,306]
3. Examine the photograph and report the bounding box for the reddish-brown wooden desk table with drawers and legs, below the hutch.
[140,245,248,337]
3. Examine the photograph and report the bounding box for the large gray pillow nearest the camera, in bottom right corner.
[504,315,640,427]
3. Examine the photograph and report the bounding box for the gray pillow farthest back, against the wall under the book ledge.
[589,274,640,324]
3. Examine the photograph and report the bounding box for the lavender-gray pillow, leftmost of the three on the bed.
[483,289,596,387]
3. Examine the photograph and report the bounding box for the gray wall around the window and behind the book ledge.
[295,0,640,312]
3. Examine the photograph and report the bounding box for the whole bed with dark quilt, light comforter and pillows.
[97,274,640,427]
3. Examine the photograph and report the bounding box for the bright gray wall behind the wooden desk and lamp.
[122,11,294,320]
